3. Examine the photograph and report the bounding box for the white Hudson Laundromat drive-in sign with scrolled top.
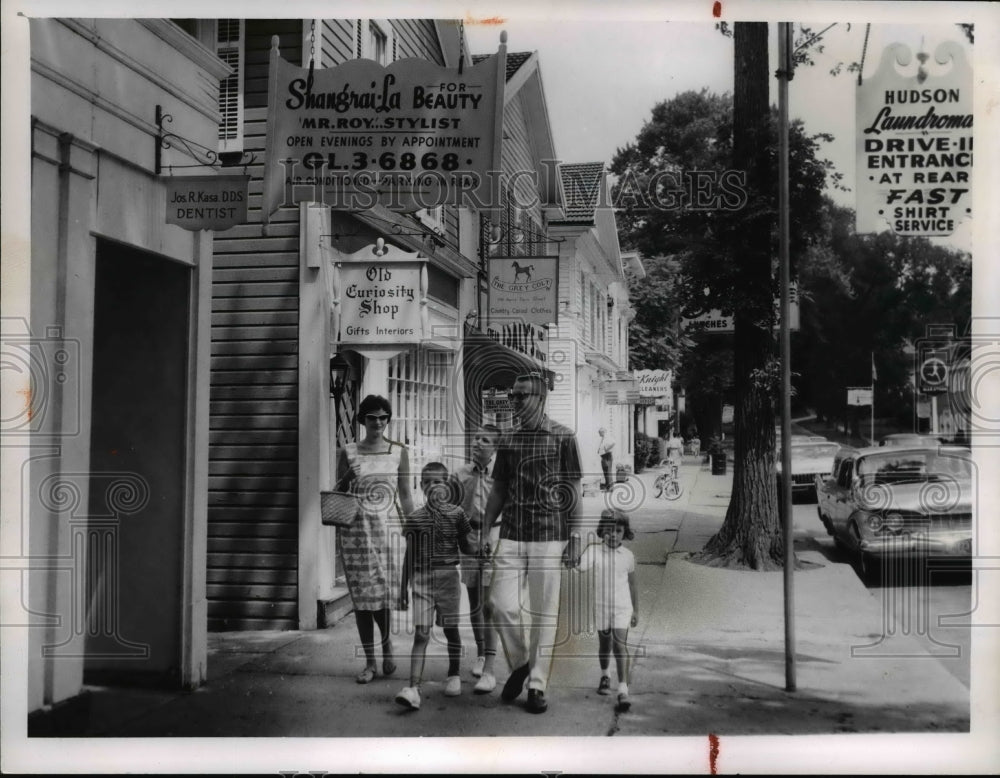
[855,42,973,236]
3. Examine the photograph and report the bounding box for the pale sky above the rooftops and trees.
[465,13,973,251]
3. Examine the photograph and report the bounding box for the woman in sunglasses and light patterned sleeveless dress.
[336,394,413,683]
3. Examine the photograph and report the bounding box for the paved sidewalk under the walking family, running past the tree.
[31,457,969,737]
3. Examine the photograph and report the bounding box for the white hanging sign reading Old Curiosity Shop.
[337,262,423,343]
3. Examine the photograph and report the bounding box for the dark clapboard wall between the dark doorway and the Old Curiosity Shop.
[207,25,302,630]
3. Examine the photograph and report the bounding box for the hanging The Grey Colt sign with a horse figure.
[489,257,559,326]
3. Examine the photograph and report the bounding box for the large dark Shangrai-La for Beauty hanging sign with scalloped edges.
[264,41,506,219]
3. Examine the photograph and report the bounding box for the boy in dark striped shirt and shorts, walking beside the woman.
[396,462,477,710]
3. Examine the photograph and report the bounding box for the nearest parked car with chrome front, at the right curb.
[816,445,973,581]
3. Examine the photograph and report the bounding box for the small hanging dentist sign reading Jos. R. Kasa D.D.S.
[164,176,250,232]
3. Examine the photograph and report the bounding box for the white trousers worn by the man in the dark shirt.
[490,539,566,691]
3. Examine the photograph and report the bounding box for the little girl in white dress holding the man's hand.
[578,508,639,712]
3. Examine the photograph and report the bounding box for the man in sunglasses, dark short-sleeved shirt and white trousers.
[483,373,582,713]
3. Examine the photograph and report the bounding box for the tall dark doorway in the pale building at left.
[84,240,192,686]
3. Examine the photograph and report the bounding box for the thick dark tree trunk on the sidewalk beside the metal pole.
[696,22,782,570]
